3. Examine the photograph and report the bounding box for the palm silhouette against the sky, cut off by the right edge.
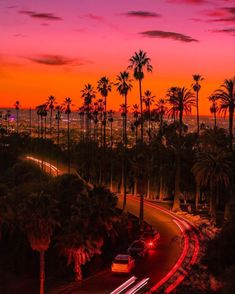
[214,77,235,150]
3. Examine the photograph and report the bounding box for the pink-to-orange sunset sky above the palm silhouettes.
[0,0,235,114]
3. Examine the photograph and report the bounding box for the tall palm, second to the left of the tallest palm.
[97,76,112,147]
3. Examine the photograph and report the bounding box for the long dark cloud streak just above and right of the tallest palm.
[139,30,198,43]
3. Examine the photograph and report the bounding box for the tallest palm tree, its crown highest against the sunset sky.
[128,50,153,143]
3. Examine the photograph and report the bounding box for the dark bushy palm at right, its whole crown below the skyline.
[192,152,233,222]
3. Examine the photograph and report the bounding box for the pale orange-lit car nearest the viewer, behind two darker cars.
[111,254,135,273]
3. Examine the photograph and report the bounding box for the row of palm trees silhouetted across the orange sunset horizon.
[2,50,235,220]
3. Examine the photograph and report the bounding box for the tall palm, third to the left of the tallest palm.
[81,83,95,139]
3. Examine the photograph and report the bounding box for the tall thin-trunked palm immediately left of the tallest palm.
[115,71,132,210]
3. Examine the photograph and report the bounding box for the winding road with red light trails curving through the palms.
[27,157,200,294]
